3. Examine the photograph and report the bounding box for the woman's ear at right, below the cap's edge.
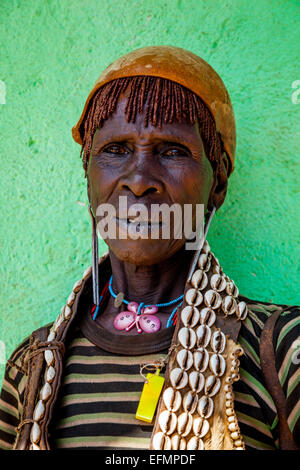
[207,152,229,211]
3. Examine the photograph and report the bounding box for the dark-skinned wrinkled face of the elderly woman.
[87,93,214,265]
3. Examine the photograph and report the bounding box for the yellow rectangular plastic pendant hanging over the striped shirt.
[135,369,165,423]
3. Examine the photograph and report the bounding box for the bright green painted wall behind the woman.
[0,0,300,378]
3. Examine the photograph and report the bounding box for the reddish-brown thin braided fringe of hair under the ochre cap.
[80,76,222,174]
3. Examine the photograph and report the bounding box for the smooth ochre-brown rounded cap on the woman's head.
[72,46,236,172]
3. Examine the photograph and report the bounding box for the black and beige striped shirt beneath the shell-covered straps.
[0,298,300,450]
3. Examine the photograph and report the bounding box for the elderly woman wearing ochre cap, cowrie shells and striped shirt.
[0,46,300,450]
